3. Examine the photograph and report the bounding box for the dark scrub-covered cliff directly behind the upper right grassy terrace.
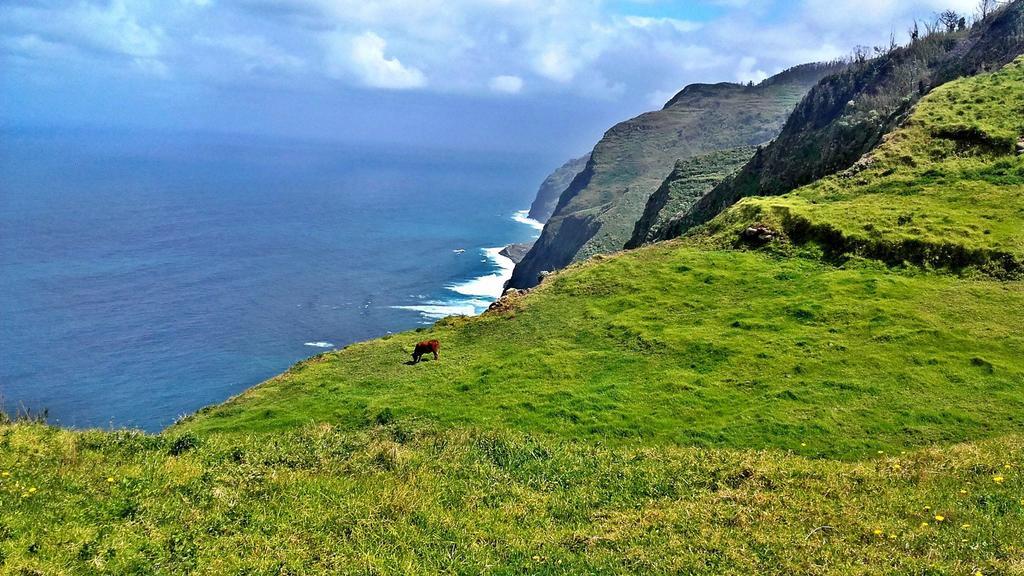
[656,0,1024,240]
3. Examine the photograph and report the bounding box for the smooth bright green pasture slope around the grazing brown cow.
[180,245,1024,457]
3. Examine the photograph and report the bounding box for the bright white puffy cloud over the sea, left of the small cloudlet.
[327,32,427,90]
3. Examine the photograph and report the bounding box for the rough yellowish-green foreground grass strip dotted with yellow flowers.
[0,424,1024,575]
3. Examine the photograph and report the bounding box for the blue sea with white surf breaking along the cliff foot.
[0,130,550,430]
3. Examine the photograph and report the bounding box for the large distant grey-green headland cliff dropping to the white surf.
[509,65,841,288]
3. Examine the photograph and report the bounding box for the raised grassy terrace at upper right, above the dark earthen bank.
[710,58,1024,273]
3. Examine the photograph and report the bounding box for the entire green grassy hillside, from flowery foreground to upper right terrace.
[0,47,1024,575]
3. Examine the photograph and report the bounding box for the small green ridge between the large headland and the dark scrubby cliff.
[626,147,757,248]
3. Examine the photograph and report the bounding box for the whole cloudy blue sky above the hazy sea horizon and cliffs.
[0,0,977,156]
